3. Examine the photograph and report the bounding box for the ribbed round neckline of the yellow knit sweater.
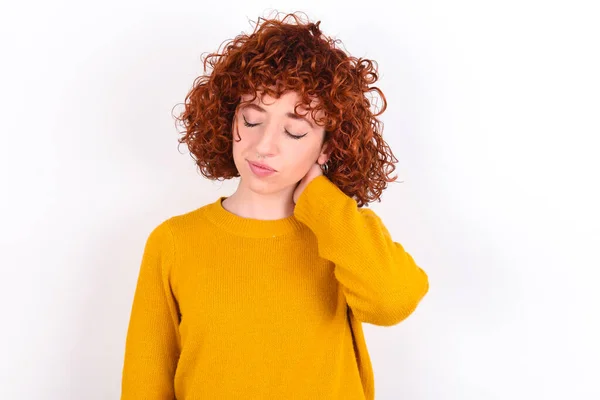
[206,196,302,238]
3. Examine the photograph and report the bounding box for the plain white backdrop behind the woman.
[0,0,600,400]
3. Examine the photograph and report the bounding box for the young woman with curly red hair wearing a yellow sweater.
[121,14,429,400]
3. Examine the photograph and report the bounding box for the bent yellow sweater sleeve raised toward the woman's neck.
[294,175,429,326]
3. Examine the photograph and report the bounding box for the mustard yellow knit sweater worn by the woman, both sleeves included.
[121,176,429,400]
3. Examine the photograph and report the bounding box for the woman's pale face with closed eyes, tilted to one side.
[233,92,327,194]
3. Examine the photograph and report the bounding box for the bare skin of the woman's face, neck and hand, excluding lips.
[223,92,328,220]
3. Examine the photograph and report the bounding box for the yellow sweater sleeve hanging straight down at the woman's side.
[121,221,180,400]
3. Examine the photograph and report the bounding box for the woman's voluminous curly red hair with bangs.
[175,13,398,207]
